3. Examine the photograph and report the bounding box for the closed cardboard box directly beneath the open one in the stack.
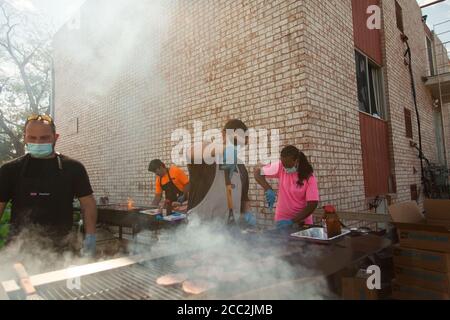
[393,246,450,273]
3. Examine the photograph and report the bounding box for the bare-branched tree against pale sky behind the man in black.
[0,0,53,162]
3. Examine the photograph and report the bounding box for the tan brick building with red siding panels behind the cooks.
[54,0,450,222]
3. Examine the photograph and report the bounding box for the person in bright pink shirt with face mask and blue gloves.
[254,146,320,229]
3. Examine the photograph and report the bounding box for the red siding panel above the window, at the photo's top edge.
[352,0,383,66]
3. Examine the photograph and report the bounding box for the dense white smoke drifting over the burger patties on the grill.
[130,224,334,300]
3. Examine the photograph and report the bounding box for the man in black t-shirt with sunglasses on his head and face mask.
[0,115,97,255]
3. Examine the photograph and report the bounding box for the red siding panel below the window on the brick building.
[360,112,391,197]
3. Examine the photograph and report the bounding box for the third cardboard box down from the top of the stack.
[394,266,450,293]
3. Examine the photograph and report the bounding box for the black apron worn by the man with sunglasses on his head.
[10,154,74,241]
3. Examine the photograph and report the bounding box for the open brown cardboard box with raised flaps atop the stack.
[389,200,450,253]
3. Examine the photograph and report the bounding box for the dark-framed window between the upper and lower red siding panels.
[355,51,385,119]
